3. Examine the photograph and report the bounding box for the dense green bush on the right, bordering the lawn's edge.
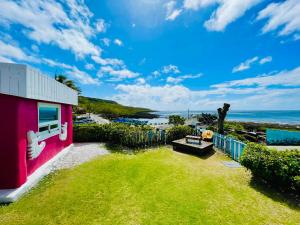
[241,143,300,193]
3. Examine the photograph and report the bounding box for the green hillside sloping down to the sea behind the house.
[75,96,157,119]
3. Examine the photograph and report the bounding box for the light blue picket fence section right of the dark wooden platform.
[213,134,246,161]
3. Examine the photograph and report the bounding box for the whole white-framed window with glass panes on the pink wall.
[38,102,61,141]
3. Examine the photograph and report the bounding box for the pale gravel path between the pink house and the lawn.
[53,143,110,170]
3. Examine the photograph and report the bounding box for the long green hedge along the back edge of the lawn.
[73,123,193,148]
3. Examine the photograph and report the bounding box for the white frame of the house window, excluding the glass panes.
[38,102,61,141]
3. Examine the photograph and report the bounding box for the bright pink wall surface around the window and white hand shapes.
[0,94,73,189]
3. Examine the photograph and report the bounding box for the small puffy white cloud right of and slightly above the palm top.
[98,66,140,81]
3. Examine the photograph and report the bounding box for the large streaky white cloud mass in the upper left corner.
[0,0,101,57]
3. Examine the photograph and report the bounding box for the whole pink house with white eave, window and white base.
[0,63,78,202]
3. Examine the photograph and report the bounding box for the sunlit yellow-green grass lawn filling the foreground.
[0,148,300,225]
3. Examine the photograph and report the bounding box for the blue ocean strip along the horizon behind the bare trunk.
[156,110,300,125]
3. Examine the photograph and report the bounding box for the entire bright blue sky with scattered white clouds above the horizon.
[0,0,300,110]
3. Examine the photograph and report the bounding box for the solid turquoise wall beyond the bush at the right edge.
[267,129,300,145]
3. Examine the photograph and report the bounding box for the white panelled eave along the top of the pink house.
[0,63,78,105]
